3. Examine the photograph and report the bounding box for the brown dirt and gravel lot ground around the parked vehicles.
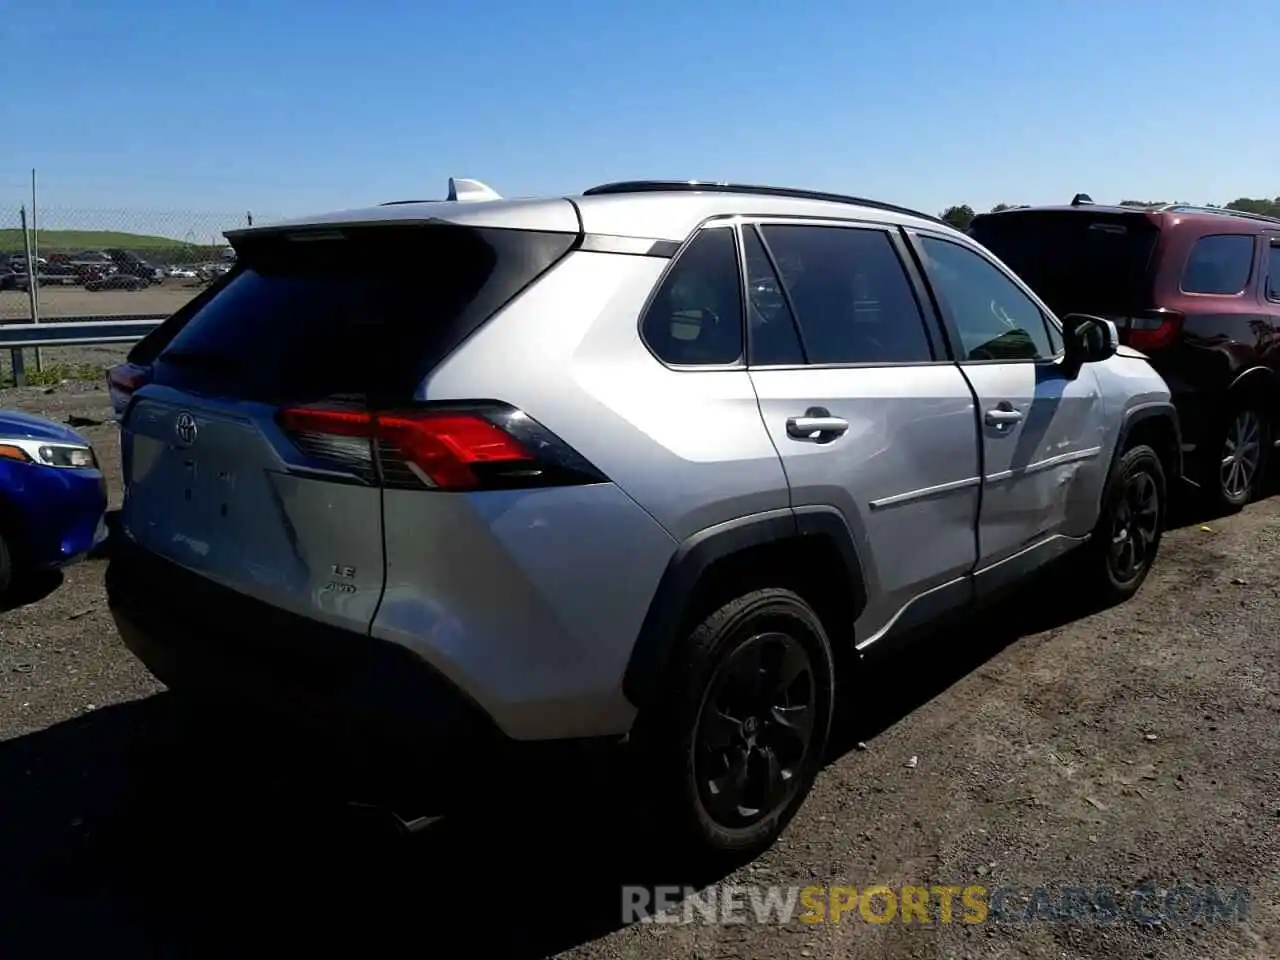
[0,384,1280,960]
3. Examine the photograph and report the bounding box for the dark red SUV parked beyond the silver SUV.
[970,202,1280,509]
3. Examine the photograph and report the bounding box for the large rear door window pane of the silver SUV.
[764,224,933,364]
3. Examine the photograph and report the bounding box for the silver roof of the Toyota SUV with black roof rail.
[227,180,964,242]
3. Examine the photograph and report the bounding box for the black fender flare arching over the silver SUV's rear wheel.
[622,506,867,708]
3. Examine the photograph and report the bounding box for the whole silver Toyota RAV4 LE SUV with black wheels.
[108,180,1181,855]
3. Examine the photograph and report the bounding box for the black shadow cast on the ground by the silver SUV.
[0,578,1121,957]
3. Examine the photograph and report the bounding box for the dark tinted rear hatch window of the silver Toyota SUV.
[146,223,576,403]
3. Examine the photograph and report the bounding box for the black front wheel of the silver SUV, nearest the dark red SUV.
[1080,444,1167,607]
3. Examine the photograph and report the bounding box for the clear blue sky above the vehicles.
[0,0,1280,225]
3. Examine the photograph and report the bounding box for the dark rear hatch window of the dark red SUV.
[972,210,1160,316]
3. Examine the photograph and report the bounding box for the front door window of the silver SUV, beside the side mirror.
[920,237,1056,360]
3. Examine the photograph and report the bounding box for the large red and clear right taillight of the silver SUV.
[276,403,604,490]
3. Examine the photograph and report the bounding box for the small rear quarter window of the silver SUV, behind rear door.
[641,227,742,365]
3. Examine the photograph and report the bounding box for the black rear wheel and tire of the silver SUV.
[639,589,835,860]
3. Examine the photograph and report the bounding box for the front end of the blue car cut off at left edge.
[0,411,106,596]
